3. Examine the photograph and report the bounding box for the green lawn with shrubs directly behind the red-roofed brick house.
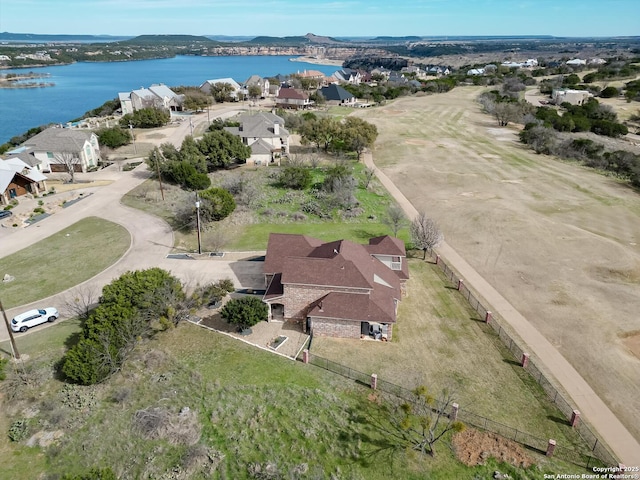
[122,161,409,251]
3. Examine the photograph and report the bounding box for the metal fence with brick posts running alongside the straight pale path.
[432,253,618,466]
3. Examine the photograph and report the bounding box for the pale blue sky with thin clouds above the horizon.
[0,0,640,37]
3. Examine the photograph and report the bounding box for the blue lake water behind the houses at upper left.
[0,56,338,144]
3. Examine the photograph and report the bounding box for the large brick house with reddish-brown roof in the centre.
[263,233,409,340]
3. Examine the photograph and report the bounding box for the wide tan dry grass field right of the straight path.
[356,87,640,439]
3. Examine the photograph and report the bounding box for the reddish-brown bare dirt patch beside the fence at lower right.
[452,428,534,468]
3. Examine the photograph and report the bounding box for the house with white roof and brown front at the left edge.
[0,157,47,205]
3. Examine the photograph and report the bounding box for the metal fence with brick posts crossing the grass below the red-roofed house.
[308,352,617,468]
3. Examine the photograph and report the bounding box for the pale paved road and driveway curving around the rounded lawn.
[0,108,264,341]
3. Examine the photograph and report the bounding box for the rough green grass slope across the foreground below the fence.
[0,322,580,480]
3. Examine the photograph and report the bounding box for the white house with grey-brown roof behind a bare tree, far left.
[22,127,100,172]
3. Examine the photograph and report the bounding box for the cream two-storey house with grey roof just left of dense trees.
[225,112,289,165]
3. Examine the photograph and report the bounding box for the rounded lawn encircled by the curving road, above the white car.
[0,217,131,308]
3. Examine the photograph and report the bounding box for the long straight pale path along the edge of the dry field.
[364,152,640,466]
